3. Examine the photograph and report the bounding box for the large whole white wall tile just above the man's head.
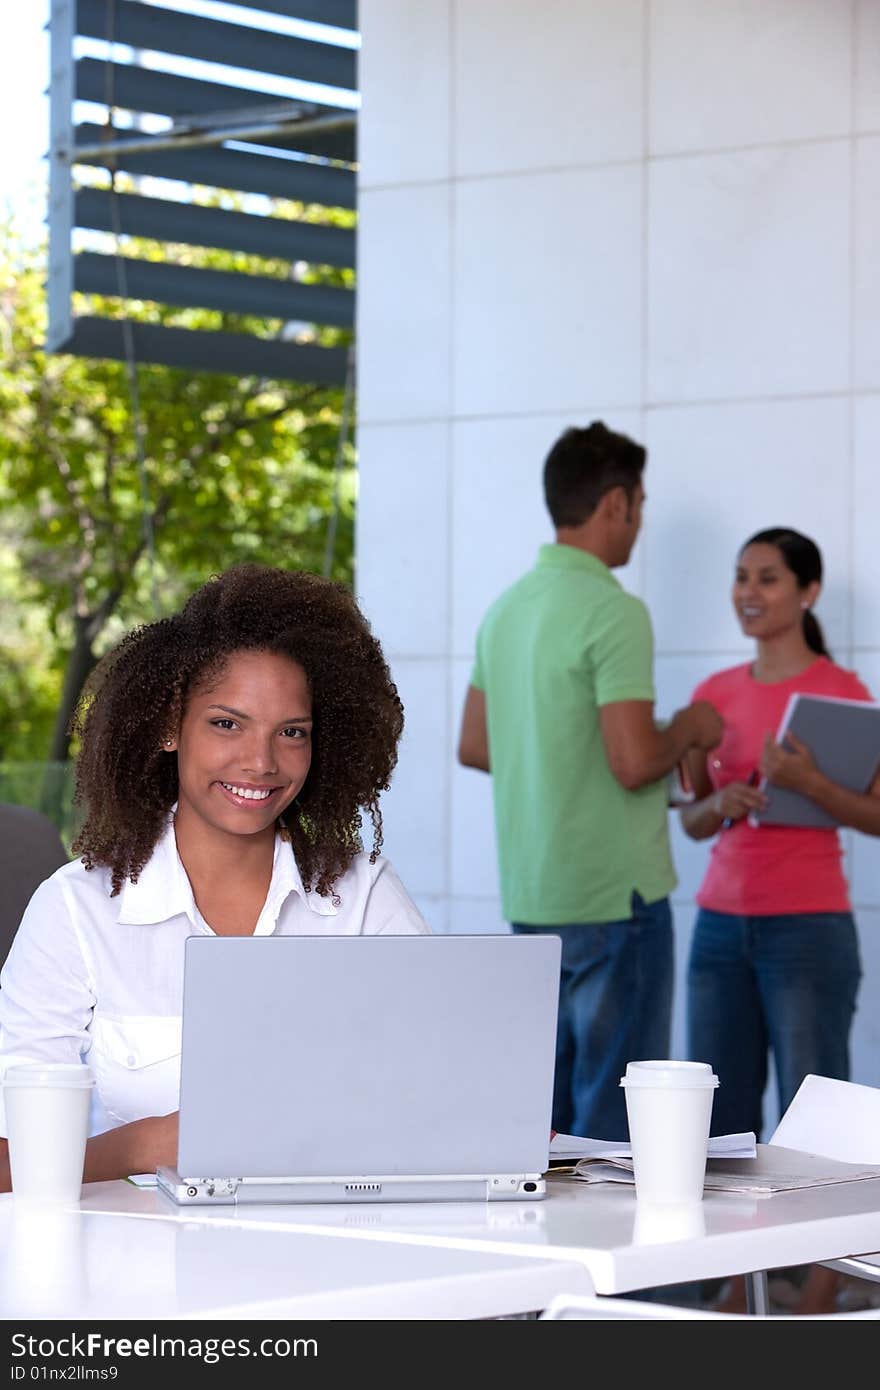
[452,164,642,417]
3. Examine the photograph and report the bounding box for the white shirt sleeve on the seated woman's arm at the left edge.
[0,874,95,1136]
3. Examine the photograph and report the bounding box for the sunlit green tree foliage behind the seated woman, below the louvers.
[0,210,355,762]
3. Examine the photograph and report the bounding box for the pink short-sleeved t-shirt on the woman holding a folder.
[692,656,872,917]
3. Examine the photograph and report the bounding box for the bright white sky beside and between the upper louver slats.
[0,0,357,240]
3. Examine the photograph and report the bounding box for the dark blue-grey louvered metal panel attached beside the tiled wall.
[47,0,357,384]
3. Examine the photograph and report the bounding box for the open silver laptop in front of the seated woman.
[158,935,562,1204]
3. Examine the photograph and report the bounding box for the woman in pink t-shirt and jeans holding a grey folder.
[681,527,880,1136]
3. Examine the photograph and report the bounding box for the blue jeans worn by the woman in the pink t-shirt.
[687,908,862,1138]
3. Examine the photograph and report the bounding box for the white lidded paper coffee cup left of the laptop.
[3,1062,95,1202]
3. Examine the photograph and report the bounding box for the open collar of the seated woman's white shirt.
[118,808,338,935]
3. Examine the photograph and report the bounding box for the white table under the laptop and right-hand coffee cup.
[70,1177,880,1311]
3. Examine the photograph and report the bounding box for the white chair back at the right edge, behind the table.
[769,1074,880,1163]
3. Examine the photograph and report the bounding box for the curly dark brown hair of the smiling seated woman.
[71,564,403,897]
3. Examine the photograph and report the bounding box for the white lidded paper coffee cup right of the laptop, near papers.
[620,1061,719,1207]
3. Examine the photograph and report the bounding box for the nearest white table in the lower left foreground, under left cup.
[0,1183,591,1321]
